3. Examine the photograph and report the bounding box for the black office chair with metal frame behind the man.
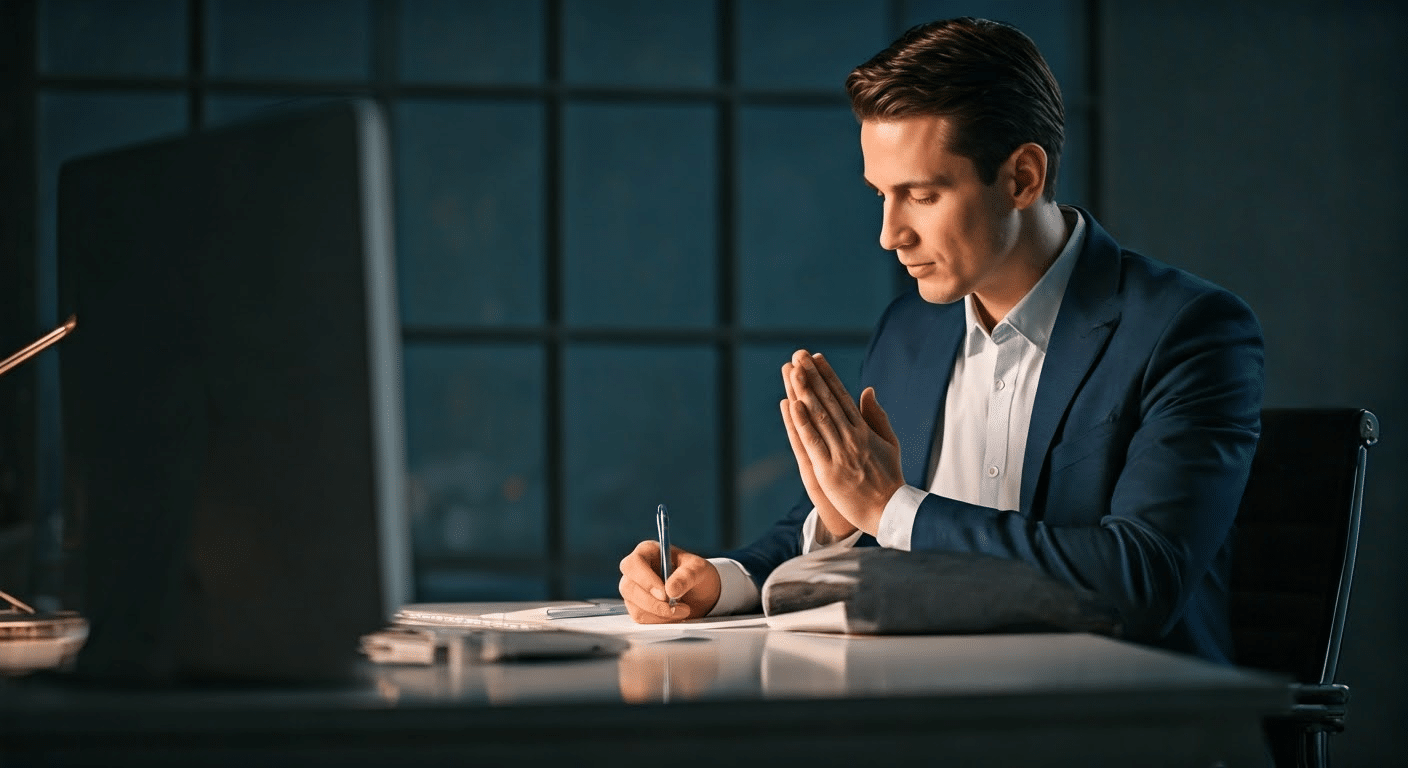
[1229,409,1378,768]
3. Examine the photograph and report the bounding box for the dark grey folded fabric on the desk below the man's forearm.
[763,547,1119,636]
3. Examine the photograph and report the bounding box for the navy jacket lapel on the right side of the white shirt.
[1021,210,1121,514]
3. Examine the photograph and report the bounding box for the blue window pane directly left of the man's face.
[739,107,895,328]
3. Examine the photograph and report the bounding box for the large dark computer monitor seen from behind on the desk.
[58,101,411,683]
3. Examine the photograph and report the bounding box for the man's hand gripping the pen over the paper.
[620,540,722,624]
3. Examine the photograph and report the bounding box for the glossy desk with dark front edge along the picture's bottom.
[0,628,1288,768]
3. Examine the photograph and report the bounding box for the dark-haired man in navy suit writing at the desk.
[621,18,1263,661]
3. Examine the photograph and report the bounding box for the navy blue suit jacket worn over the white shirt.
[725,211,1263,661]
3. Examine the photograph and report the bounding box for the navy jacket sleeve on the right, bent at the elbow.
[911,292,1263,640]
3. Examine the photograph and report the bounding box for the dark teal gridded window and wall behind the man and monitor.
[0,0,1408,765]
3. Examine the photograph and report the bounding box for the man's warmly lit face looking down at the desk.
[860,117,1019,304]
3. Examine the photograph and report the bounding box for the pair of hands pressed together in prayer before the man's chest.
[779,349,904,537]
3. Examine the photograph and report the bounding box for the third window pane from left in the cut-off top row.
[396,0,543,85]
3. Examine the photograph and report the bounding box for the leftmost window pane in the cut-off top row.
[39,0,187,76]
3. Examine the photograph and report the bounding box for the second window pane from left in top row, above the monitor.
[206,0,372,79]
